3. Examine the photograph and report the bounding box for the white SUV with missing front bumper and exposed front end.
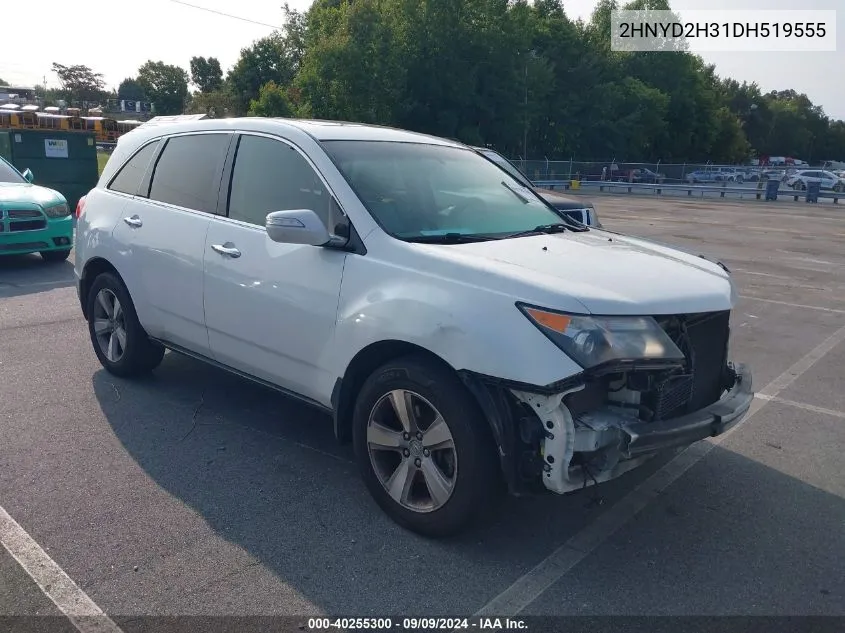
[75,118,753,535]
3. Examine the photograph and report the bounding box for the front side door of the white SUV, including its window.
[204,133,349,405]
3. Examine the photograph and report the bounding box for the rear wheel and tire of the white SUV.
[86,273,164,378]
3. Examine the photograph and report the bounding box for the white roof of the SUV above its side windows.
[125,115,464,147]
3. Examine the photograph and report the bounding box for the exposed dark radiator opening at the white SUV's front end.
[647,310,731,420]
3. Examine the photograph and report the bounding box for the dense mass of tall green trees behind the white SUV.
[181,0,845,162]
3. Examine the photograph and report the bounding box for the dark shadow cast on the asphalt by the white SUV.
[93,354,845,616]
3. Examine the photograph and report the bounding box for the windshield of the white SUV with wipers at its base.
[323,141,561,240]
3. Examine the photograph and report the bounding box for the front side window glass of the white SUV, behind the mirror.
[228,134,348,234]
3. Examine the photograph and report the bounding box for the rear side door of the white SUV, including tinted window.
[115,132,232,354]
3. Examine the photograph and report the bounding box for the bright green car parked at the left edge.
[0,158,73,262]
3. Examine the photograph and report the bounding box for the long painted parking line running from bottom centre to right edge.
[475,318,845,617]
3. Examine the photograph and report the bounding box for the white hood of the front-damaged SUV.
[419,230,734,315]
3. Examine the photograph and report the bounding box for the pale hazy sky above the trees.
[0,0,845,119]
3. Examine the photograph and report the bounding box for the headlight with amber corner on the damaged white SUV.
[517,304,684,369]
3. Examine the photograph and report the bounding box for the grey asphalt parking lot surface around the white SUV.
[0,194,845,632]
